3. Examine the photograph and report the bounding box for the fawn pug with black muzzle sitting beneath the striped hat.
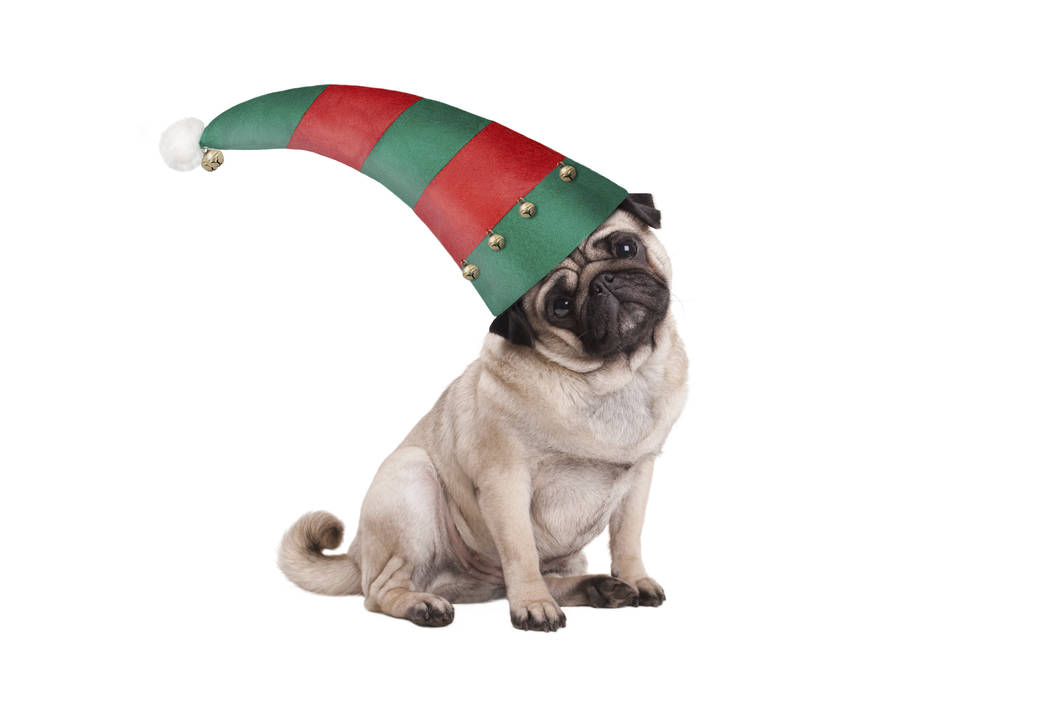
[278,194,688,632]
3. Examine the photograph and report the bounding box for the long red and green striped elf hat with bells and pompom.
[161,85,627,315]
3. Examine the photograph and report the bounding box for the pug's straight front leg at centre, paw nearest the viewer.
[476,462,565,632]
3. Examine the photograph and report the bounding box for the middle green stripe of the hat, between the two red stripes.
[361,99,490,208]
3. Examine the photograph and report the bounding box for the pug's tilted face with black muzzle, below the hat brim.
[489,194,671,367]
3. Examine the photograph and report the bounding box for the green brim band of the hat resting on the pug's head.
[467,158,627,315]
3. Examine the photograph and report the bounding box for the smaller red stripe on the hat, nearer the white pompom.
[288,85,419,171]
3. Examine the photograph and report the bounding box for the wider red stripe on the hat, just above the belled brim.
[415,122,563,263]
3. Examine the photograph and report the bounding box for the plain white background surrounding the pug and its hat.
[0,2,1050,703]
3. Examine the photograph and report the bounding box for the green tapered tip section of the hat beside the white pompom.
[201,85,328,149]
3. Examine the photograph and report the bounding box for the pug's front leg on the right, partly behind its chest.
[609,456,667,606]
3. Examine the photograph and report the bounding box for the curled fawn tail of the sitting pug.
[277,511,361,596]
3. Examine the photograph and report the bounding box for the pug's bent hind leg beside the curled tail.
[357,447,455,627]
